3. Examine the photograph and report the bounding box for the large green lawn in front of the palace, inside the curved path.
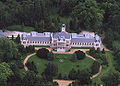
[28,54,94,74]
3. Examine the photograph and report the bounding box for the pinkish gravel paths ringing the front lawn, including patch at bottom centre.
[24,47,102,86]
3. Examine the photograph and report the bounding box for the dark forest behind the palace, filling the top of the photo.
[0,0,120,49]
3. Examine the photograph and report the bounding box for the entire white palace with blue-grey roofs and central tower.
[21,24,101,52]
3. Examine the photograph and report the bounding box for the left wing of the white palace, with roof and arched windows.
[21,32,51,46]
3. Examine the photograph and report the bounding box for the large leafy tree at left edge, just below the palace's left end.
[0,38,20,62]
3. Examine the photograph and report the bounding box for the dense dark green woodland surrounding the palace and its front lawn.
[0,0,120,86]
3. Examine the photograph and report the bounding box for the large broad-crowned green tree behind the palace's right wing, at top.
[72,0,104,31]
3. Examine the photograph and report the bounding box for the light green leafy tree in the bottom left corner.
[0,62,13,83]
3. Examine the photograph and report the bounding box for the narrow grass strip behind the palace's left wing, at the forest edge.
[7,25,34,32]
